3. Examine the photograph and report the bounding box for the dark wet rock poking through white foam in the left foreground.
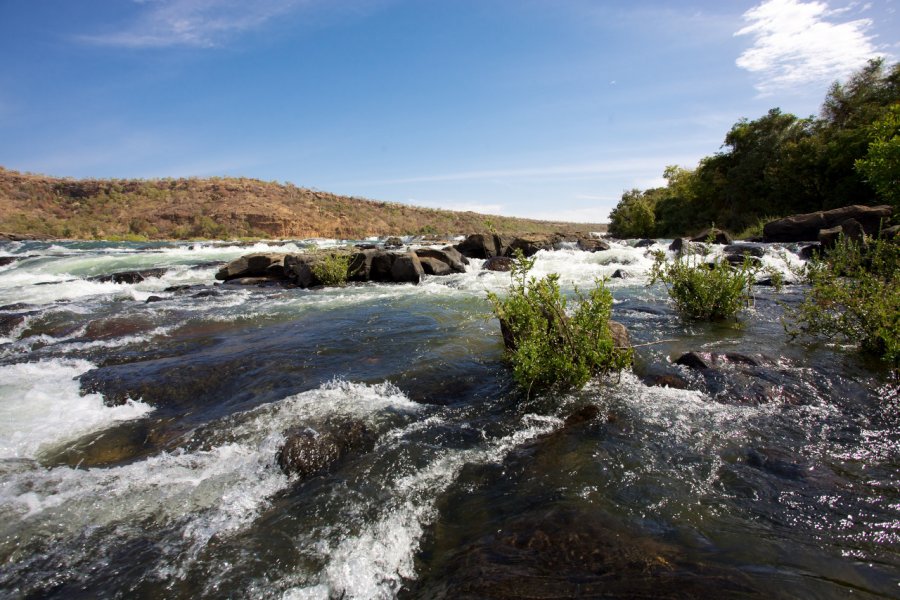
[275,421,374,478]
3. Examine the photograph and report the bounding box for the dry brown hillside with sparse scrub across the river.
[0,167,605,239]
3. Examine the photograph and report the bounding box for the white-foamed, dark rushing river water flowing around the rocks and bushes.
[0,240,900,599]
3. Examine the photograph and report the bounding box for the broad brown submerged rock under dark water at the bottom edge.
[411,508,754,600]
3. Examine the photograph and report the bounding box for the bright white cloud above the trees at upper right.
[734,0,882,95]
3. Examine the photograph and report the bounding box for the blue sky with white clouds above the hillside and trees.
[0,0,900,222]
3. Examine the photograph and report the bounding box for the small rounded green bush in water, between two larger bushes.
[650,251,758,321]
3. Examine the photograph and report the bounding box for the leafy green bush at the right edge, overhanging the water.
[785,238,900,370]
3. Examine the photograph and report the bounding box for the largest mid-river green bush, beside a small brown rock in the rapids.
[488,251,632,395]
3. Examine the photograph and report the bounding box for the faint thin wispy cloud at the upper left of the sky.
[79,0,311,48]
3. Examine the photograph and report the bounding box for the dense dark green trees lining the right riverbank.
[609,59,900,237]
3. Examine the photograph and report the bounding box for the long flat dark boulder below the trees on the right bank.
[763,204,893,242]
